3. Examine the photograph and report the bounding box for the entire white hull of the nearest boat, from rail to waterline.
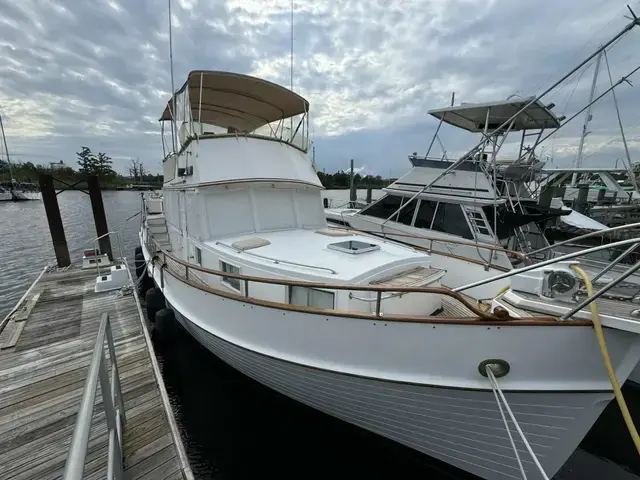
[143,240,640,479]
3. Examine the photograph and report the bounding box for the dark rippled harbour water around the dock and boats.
[0,192,640,480]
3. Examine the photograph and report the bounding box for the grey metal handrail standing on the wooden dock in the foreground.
[63,313,126,480]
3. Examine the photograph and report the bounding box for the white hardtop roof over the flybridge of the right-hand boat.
[428,97,562,133]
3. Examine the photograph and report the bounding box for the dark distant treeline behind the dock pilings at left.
[0,146,162,189]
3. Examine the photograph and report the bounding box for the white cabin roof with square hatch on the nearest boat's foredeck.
[205,229,430,281]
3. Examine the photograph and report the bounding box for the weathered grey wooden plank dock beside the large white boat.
[0,265,193,480]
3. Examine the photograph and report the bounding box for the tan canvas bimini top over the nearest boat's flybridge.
[160,70,309,132]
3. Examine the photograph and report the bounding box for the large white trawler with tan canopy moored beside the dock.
[139,65,640,479]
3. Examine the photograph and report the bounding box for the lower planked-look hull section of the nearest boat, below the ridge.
[175,304,611,480]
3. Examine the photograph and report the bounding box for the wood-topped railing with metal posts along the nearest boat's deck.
[147,236,552,324]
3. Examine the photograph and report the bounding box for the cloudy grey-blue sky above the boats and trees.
[0,0,640,176]
